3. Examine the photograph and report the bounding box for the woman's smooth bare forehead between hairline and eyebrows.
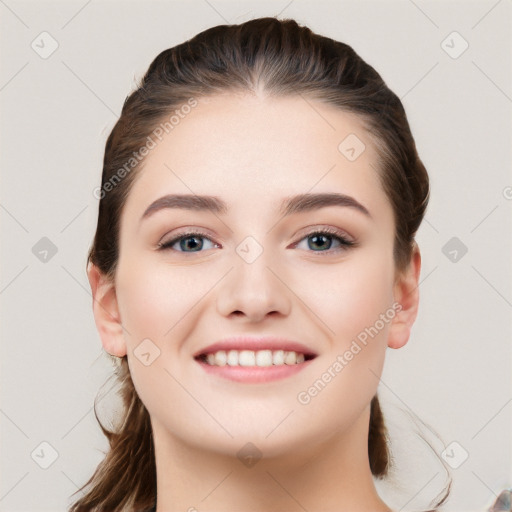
[122,93,387,220]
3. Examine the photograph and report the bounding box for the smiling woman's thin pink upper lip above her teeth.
[194,336,317,357]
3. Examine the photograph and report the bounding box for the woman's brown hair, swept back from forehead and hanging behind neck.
[70,17,448,512]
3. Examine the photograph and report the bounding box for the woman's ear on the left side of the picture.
[87,263,126,357]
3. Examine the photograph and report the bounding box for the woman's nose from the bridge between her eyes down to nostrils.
[217,236,290,320]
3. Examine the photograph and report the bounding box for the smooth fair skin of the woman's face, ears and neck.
[88,91,421,512]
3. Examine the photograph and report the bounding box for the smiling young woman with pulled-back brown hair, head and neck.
[71,18,446,512]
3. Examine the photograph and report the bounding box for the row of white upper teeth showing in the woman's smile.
[206,350,305,367]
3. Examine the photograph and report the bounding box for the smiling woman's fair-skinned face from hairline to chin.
[95,93,416,456]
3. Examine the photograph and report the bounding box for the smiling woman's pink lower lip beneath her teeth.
[196,359,314,383]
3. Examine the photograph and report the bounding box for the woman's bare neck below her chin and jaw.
[152,410,391,512]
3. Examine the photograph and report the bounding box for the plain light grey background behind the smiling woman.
[0,0,512,512]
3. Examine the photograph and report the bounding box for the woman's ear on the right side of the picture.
[388,242,421,348]
